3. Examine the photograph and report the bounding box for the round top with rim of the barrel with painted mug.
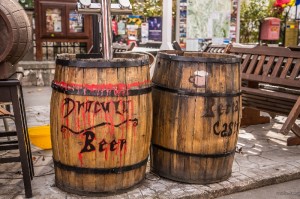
[157,50,241,64]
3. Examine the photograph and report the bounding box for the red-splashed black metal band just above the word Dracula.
[51,82,152,97]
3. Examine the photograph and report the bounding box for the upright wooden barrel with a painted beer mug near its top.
[150,51,241,184]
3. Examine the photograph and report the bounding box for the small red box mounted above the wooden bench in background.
[260,17,280,40]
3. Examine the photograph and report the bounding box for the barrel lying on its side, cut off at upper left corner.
[0,0,32,64]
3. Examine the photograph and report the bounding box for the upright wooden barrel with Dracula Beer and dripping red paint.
[50,53,152,195]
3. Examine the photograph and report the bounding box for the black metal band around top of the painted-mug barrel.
[157,53,241,64]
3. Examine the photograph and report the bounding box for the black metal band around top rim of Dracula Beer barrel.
[56,58,149,68]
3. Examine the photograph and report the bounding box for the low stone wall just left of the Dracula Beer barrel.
[17,61,55,86]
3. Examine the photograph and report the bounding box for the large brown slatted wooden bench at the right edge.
[226,46,300,145]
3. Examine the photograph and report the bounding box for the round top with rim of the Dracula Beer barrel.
[56,52,149,68]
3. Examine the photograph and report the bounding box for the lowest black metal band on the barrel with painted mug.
[151,144,235,158]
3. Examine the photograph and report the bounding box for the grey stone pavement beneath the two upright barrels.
[0,88,300,199]
